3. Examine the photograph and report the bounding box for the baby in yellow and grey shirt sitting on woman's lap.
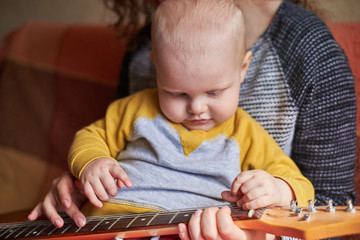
[69,0,314,215]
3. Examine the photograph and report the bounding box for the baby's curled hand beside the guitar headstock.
[222,169,293,209]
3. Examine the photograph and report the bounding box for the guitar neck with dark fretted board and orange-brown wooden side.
[0,206,263,239]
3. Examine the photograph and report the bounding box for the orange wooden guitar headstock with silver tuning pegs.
[236,201,360,239]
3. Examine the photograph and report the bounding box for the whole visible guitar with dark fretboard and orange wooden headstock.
[0,206,360,239]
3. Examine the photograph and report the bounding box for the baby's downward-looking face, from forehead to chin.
[152,45,241,131]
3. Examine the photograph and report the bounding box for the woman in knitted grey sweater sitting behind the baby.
[29,0,356,239]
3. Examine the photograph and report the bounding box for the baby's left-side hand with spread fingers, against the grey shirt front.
[80,158,132,208]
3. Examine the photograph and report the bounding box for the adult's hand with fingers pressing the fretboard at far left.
[28,172,87,228]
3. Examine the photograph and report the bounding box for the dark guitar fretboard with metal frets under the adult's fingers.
[0,206,263,239]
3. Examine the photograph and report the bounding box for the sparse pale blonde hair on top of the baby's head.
[152,0,245,62]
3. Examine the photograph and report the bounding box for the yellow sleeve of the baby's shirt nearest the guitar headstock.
[235,109,315,205]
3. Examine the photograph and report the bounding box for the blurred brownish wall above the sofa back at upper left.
[0,0,114,41]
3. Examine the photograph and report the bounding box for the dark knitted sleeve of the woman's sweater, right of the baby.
[255,1,356,205]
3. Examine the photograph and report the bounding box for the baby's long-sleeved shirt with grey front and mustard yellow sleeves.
[69,89,314,214]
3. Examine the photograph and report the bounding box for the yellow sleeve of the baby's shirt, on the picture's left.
[68,90,158,178]
